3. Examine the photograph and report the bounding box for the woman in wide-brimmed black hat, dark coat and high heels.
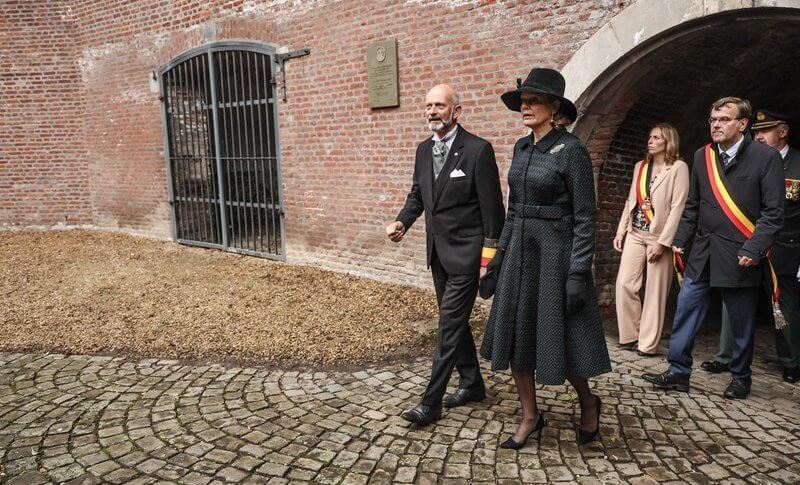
[481,69,611,449]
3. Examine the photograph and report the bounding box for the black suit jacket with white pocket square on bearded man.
[397,125,505,274]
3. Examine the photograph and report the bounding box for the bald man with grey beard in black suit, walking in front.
[386,84,505,425]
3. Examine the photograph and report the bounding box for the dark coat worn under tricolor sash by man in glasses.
[672,137,784,288]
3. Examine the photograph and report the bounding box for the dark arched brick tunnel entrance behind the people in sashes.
[573,8,800,309]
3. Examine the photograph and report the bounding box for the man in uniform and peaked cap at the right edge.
[702,109,800,383]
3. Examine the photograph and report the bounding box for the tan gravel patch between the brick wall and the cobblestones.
[0,230,487,365]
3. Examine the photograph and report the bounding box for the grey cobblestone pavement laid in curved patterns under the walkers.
[0,326,800,484]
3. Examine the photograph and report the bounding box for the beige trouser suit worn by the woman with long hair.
[616,160,689,354]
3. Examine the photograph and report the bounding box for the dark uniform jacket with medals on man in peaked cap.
[772,147,800,277]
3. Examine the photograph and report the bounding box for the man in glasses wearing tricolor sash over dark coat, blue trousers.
[643,97,784,399]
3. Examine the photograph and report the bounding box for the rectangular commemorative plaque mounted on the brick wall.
[367,39,400,108]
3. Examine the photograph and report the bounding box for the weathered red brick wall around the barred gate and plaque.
[3,0,631,284]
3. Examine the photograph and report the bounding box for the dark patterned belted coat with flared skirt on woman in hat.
[481,130,611,384]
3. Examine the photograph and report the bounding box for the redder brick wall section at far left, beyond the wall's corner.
[0,0,91,226]
